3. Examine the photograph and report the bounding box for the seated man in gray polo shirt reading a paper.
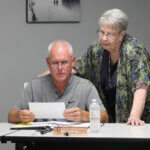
[8,40,108,123]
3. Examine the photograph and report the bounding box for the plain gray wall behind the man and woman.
[0,0,150,150]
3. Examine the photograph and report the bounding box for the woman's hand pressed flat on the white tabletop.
[127,116,145,126]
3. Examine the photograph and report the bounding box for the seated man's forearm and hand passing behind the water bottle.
[64,107,108,123]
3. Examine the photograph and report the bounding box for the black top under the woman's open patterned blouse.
[100,50,118,122]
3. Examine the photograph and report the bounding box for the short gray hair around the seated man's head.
[48,40,73,57]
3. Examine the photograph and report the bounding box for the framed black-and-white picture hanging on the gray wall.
[26,0,80,23]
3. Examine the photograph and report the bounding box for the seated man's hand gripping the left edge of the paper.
[20,110,35,123]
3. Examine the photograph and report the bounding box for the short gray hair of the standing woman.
[98,9,128,32]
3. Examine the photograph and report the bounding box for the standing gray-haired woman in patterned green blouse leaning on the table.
[75,9,150,125]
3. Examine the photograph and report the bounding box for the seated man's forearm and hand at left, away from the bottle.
[8,109,35,123]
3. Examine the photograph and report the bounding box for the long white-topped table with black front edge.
[3,123,150,150]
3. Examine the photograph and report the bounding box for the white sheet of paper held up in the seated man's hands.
[29,102,65,119]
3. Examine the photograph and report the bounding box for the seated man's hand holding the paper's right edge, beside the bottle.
[64,107,89,121]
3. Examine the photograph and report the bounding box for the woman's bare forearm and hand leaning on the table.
[127,86,149,125]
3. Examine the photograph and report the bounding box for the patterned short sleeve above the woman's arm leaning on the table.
[130,47,150,92]
